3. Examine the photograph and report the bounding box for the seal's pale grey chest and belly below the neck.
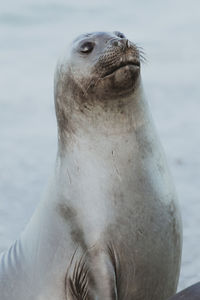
[54,134,181,300]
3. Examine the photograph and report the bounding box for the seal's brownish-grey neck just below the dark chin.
[57,84,148,152]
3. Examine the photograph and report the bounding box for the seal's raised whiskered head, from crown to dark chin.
[56,31,143,100]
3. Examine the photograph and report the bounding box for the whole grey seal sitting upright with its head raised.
[0,32,182,300]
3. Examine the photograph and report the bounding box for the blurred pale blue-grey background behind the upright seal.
[0,0,200,289]
